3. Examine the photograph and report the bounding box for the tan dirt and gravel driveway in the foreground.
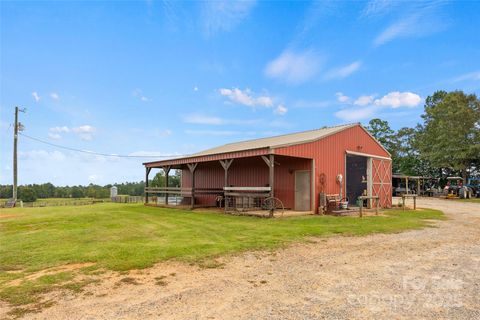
[16,199,480,319]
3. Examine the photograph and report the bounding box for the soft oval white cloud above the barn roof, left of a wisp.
[265,50,322,84]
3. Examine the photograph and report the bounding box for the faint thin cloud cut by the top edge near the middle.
[202,0,255,35]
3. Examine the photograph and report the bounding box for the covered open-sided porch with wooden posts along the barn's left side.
[144,150,315,214]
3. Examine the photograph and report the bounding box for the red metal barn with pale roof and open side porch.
[144,124,392,212]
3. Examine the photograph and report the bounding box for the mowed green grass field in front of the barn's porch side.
[0,203,444,305]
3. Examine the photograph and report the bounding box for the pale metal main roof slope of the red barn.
[189,123,359,157]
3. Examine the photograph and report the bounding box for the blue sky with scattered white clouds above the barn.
[0,1,480,185]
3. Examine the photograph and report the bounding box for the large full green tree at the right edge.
[416,91,480,179]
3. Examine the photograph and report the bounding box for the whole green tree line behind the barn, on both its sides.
[0,91,480,202]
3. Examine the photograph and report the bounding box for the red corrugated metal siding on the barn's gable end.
[274,126,391,208]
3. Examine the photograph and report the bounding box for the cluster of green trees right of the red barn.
[367,91,480,181]
